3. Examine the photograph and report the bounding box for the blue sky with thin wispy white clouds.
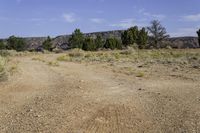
[0,0,200,38]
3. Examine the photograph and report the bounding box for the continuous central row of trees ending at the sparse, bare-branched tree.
[60,20,169,51]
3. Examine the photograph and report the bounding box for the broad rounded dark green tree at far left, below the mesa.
[7,36,27,51]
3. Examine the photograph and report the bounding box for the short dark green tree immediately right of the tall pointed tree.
[82,37,96,51]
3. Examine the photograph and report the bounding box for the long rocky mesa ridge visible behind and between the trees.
[0,30,200,50]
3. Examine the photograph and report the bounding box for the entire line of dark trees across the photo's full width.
[0,20,200,51]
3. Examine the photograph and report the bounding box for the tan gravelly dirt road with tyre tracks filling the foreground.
[0,54,200,133]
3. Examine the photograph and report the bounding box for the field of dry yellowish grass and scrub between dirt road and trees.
[57,48,200,78]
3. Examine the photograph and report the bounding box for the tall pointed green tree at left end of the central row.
[69,29,84,49]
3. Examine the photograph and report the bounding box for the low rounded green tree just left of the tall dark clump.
[104,38,122,50]
